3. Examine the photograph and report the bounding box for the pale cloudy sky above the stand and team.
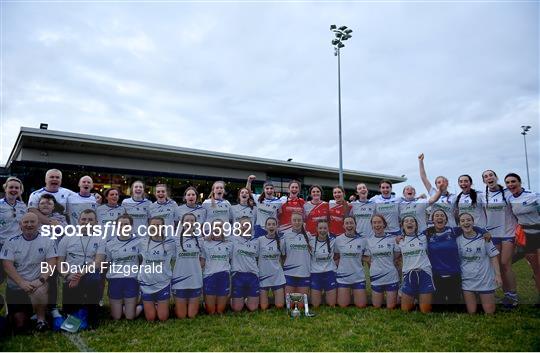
[0,0,540,193]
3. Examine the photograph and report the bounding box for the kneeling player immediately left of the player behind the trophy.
[258,217,285,310]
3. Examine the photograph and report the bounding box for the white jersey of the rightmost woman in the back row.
[508,190,540,235]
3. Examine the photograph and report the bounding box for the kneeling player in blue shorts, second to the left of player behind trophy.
[231,217,260,312]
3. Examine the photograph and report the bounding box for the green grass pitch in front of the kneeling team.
[0,260,540,351]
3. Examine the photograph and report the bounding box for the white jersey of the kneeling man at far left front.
[0,233,57,289]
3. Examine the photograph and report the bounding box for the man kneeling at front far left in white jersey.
[0,213,57,332]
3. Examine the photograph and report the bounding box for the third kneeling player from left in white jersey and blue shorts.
[171,213,203,319]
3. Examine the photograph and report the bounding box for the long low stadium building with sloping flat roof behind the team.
[1,127,406,201]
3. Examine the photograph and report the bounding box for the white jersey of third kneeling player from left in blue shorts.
[171,236,203,289]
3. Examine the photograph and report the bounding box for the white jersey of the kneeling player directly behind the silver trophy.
[280,228,311,277]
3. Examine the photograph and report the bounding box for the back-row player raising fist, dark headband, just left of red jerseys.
[246,175,285,237]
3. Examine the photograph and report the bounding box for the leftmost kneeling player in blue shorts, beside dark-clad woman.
[105,214,143,320]
